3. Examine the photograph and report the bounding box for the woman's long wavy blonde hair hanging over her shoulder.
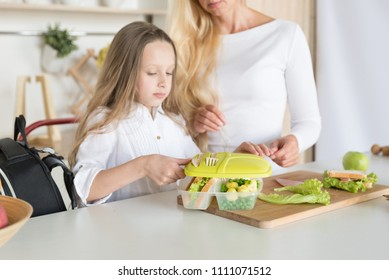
[168,0,220,151]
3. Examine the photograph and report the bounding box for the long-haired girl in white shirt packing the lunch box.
[69,22,199,206]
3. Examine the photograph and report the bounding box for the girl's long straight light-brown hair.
[69,21,181,167]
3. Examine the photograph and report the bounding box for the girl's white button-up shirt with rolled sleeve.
[73,105,199,205]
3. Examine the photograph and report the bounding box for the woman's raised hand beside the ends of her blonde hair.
[192,105,226,133]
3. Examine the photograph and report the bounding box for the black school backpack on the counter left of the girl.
[0,115,76,217]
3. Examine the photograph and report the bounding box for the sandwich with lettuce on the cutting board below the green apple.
[323,170,377,193]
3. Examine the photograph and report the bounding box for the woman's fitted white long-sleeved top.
[208,20,321,152]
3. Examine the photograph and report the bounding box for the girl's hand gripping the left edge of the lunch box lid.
[145,155,191,186]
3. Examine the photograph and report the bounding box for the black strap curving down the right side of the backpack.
[42,154,76,209]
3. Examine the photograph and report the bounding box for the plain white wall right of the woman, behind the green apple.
[316,0,389,160]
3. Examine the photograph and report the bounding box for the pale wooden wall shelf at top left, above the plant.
[0,3,166,16]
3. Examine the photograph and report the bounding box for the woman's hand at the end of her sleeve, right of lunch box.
[270,135,299,167]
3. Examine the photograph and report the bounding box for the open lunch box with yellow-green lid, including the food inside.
[179,152,272,210]
